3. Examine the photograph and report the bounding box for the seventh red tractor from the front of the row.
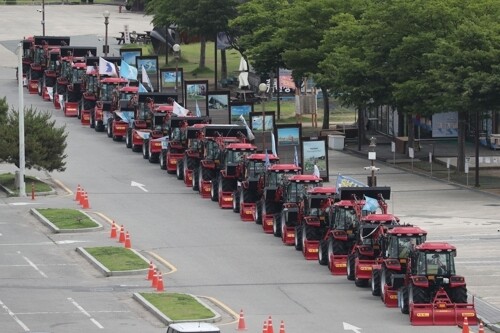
[254,164,302,232]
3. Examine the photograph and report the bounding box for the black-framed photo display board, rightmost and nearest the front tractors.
[302,136,329,182]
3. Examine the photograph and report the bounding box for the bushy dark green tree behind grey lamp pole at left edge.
[0,97,68,172]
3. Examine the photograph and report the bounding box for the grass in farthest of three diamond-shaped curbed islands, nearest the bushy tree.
[37,208,99,229]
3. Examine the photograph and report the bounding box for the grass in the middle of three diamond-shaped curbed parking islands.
[85,246,149,272]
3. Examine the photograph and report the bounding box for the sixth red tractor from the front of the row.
[273,175,323,247]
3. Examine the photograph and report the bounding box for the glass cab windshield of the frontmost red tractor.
[417,252,455,276]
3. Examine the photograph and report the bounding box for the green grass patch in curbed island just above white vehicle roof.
[140,293,214,320]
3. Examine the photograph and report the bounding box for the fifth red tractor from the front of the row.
[295,187,337,260]
